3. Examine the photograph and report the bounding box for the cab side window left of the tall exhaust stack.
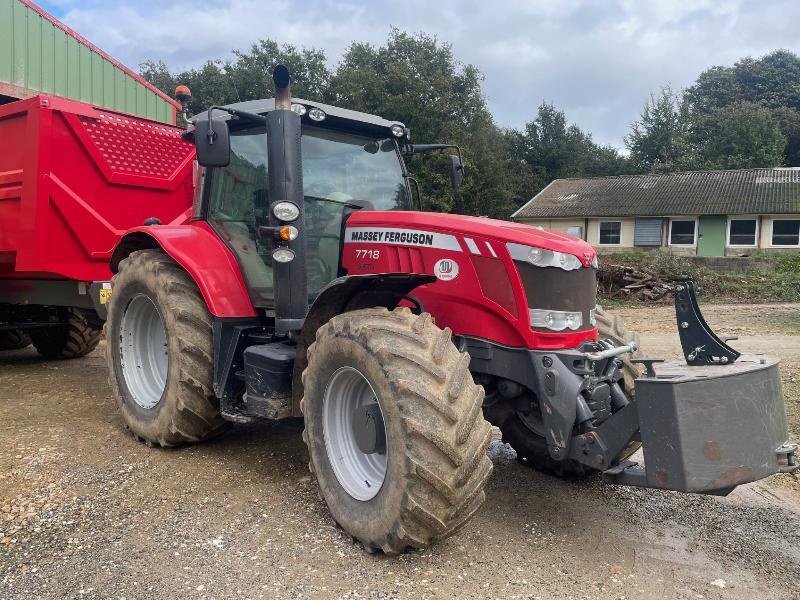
[208,129,273,306]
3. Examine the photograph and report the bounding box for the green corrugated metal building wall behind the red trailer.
[0,0,180,124]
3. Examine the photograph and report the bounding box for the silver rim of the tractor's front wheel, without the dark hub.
[322,367,389,502]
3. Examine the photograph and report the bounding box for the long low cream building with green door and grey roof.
[511,167,800,256]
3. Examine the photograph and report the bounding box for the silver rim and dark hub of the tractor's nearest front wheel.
[322,367,387,501]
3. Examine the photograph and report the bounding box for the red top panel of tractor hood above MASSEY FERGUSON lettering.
[347,210,597,266]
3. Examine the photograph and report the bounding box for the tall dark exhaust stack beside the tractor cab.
[266,65,308,335]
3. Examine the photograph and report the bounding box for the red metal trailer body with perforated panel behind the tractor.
[0,95,194,290]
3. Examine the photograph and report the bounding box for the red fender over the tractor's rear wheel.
[111,221,258,317]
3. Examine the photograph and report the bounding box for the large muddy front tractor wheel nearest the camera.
[301,308,492,554]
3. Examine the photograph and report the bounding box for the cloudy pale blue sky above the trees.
[40,0,800,147]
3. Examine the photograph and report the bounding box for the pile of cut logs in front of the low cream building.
[597,262,675,302]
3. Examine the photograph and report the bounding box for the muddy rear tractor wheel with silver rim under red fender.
[106,250,228,447]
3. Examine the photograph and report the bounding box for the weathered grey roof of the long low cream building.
[511,167,800,219]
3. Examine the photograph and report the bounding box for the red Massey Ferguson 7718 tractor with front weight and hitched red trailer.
[0,66,797,554]
